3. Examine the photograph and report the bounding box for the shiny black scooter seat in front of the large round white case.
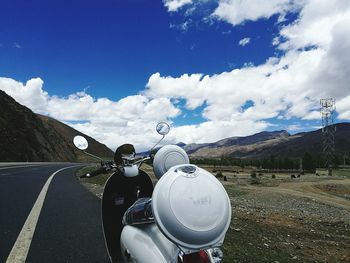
[123,198,154,225]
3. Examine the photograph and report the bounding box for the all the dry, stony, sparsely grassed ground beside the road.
[76,167,350,263]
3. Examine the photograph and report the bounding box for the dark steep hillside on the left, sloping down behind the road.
[0,90,113,162]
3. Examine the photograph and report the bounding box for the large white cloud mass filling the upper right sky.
[146,0,350,139]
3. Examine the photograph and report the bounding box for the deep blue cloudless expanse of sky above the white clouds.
[0,0,288,99]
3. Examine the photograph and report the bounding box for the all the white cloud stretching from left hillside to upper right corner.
[0,0,350,150]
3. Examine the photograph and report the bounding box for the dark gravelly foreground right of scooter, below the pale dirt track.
[224,179,350,262]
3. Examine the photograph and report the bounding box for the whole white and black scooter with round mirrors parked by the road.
[74,122,231,263]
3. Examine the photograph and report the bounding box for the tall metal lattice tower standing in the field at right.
[320,98,336,175]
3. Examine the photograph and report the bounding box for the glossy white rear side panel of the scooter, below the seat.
[120,223,180,263]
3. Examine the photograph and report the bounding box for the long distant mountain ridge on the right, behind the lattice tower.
[183,123,350,158]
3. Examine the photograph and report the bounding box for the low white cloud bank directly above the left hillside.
[0,78,180,150]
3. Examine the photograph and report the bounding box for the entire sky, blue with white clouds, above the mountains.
[0,0,350,151]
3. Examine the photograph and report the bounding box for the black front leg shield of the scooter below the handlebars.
[102,170,153,263]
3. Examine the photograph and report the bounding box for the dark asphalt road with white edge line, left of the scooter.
[0,163,109,263]
